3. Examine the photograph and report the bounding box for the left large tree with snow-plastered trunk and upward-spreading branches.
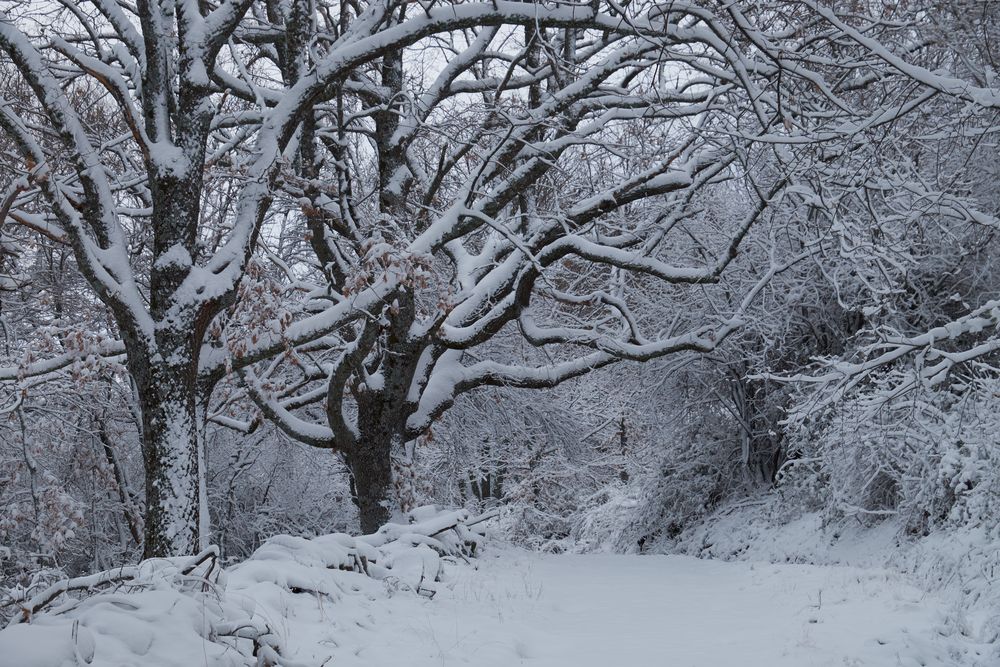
[0,0,696,556]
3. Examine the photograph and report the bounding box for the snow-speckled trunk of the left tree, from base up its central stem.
[135,103,215,558]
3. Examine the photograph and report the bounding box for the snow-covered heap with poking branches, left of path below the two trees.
[0,506,487,667]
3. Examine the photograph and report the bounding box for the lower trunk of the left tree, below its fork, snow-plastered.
[139,368,200,558]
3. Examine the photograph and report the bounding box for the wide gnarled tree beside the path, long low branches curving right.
[234,2,924,530]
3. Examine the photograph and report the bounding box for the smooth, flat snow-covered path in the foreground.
[335,550,993,667]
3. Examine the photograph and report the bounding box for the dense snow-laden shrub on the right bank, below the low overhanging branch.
[778,374,1000,534]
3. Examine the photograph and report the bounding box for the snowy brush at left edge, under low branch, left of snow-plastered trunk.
[0,370,141,585]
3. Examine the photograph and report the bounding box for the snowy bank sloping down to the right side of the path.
[653,495,1000,652]
